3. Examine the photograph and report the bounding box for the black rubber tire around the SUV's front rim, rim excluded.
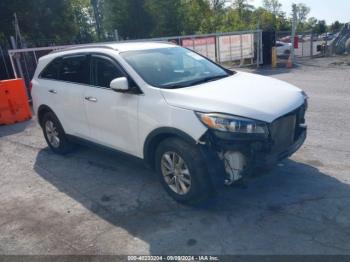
[155,138,215,205]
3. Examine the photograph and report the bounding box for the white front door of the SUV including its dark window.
[84,54,139,154]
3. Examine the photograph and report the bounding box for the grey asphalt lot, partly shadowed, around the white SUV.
[0,58,350,255]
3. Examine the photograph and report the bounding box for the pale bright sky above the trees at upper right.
[249,0,350,23]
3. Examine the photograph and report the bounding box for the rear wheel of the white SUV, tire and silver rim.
[41,112,73,154]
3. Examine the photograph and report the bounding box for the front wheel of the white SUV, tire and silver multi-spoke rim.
[156,138,214,204]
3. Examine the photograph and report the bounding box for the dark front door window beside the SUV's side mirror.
[92,56,124,88]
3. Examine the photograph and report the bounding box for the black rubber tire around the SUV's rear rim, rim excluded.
[41,112,74,155]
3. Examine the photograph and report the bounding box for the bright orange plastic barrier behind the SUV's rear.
[0,79,32,125]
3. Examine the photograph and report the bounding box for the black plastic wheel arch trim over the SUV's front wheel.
[143,127,197,169]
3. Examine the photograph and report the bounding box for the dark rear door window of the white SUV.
[59,55,90,84]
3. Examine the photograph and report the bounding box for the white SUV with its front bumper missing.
[32,42,307,203]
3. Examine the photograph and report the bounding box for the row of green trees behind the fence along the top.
[0,0,322,45]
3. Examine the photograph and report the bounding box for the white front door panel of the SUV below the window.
[84,87,139,155]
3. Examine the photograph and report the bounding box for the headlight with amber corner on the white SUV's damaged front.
[196,112,268,137]
